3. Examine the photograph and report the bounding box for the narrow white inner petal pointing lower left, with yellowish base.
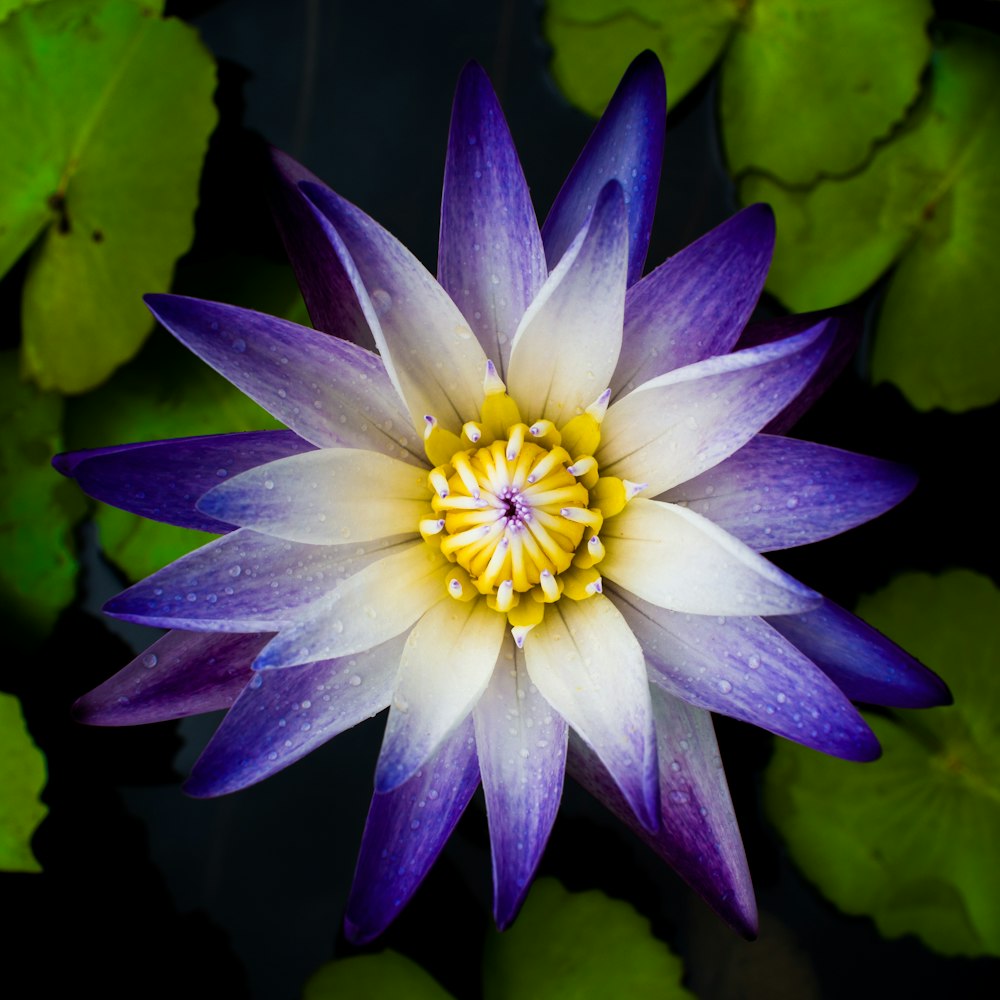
[254,541,449,669]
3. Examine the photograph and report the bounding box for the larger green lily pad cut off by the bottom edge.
[483,879,693,1000]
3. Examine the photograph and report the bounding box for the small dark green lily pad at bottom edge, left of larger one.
[302,951,451,1000]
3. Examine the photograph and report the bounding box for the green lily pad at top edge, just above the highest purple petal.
[545,0,742,117]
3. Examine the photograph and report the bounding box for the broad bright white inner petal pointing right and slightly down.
[601,497,822,615]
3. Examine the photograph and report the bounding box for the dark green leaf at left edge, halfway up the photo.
[0,352,84,639]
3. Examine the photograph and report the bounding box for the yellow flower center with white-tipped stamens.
[420,364,636,645]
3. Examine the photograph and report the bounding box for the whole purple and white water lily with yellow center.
[55,54,947,941]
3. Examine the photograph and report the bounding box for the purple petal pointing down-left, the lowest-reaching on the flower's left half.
[344,719,479,944]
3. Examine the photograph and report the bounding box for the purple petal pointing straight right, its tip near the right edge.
[659,434,917,552]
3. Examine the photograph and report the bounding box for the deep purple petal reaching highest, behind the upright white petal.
[542,52,667,284]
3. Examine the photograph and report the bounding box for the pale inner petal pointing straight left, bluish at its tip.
[198,448,431,545]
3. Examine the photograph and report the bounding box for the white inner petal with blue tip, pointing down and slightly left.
[375,596,506,793]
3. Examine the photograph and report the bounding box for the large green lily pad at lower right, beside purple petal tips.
[765,570,1000,955]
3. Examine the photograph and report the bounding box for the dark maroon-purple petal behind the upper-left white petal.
[269,149,375,350]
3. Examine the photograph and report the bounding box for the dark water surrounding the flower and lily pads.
[0,0,1000,1000]
